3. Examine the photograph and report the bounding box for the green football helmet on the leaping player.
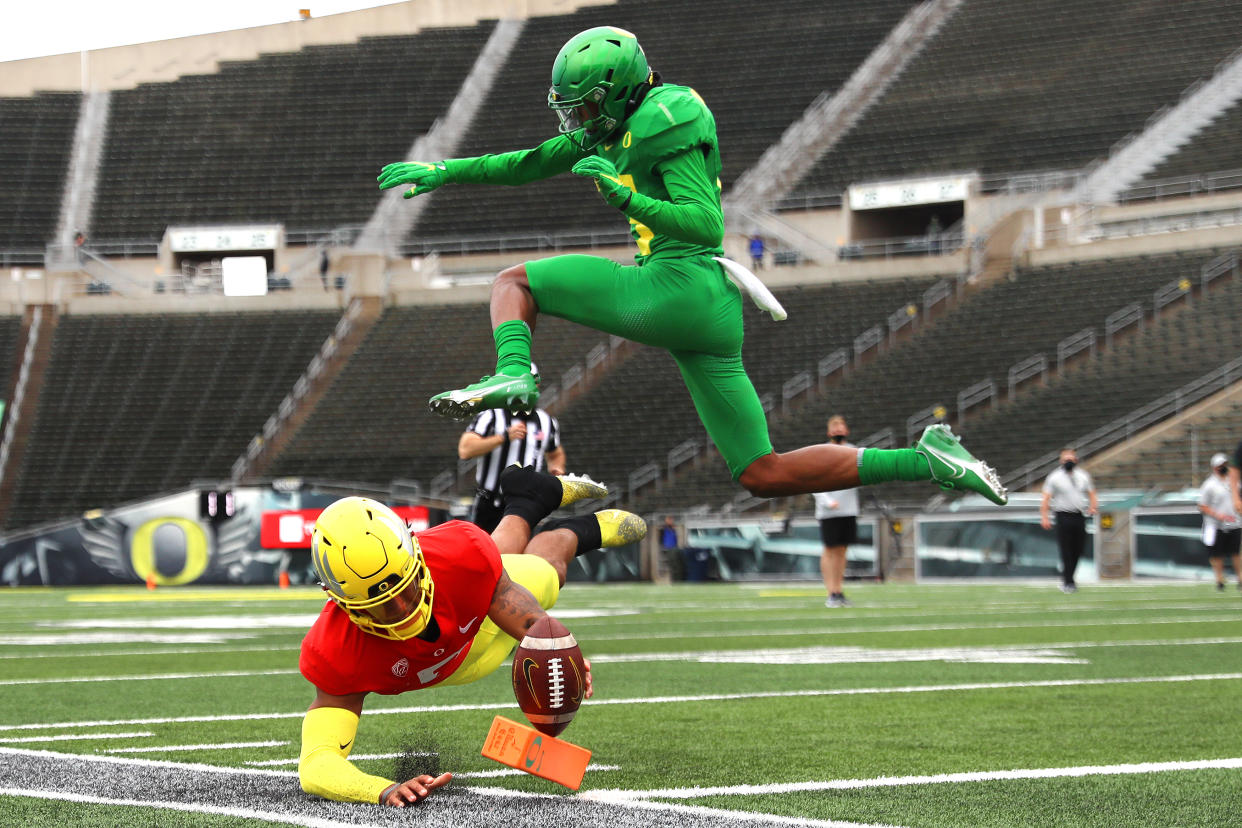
[548,26,652,149]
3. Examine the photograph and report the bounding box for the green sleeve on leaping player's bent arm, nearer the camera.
[621,149,724,247]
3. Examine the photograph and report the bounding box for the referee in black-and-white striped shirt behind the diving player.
[457,362,565,531]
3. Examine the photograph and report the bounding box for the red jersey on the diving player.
[298,520,502,695]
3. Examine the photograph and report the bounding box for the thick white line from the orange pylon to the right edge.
[579,757,1242,802]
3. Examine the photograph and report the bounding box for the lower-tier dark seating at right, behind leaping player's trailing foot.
[638,245,1237,508]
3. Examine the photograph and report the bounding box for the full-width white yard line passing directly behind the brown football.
[0,673,1242,729]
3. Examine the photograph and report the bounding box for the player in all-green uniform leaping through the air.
[379,26,1007,504]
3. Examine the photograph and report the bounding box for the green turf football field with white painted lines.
[0,583,1242,828]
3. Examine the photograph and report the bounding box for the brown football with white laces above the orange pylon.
[513,616,586,736]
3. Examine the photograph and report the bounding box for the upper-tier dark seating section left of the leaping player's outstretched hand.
[91,22,494,241]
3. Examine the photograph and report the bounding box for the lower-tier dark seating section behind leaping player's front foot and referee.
[268,303,609,485]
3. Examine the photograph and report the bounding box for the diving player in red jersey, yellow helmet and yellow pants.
[298,467,647,808]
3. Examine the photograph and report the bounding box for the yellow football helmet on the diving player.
[311,498,435,641]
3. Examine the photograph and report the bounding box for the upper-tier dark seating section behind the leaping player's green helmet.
[410,0,913,247]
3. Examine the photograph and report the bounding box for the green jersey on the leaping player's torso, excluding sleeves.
[595,84,724,263]
